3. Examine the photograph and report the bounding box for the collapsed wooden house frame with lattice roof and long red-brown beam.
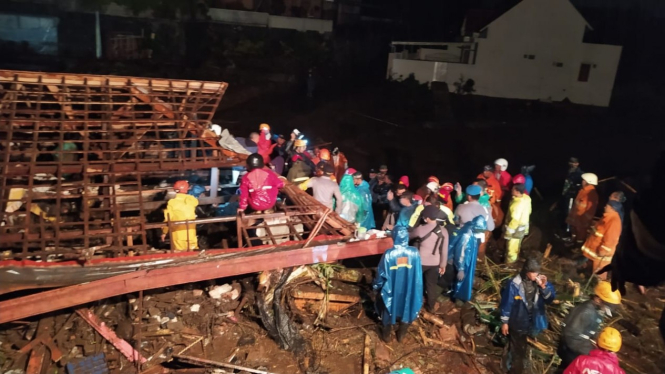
[0,70,391,323]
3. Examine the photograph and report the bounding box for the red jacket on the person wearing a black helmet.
[240,169,284,210]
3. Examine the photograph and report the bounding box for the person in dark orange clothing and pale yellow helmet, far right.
[566,173,598,244]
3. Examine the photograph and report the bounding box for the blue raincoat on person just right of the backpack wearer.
[448,216,487,302]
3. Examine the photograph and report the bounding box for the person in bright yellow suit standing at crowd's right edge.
[503,184,531,264]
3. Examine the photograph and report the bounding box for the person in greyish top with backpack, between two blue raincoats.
[409,205,448,313]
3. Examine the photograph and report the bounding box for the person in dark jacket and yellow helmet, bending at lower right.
[558,281,621,368]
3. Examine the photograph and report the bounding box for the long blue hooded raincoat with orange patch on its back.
[373,226,423,325]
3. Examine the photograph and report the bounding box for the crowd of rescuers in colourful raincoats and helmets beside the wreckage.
[165,124,625,374]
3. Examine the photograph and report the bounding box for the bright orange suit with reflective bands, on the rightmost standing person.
[582,210,621,279]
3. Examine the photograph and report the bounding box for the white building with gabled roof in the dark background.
[388,0,622,107]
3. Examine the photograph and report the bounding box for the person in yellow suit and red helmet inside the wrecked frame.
[162,180,199,252]
